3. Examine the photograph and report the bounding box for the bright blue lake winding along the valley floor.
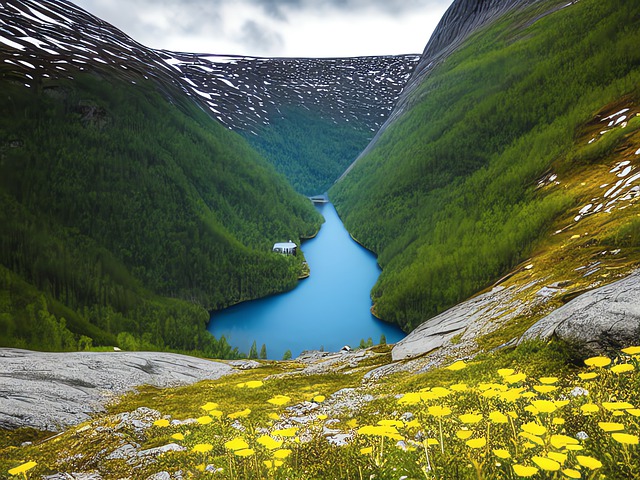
[209,203,405,359]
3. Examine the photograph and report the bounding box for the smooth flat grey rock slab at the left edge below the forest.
[0,349,245,431]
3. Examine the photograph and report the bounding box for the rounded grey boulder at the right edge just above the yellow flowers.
[520,270,640,354]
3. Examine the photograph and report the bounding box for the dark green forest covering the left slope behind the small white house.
[0,71,321,357]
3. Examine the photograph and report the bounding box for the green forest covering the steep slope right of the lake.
[330,0,640,330]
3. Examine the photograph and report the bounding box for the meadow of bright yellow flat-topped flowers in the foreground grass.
[5,346,640,480]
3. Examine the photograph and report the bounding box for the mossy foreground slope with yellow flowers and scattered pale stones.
[0,343,640,480]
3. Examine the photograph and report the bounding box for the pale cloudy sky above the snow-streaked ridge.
[71,0,452,57]
